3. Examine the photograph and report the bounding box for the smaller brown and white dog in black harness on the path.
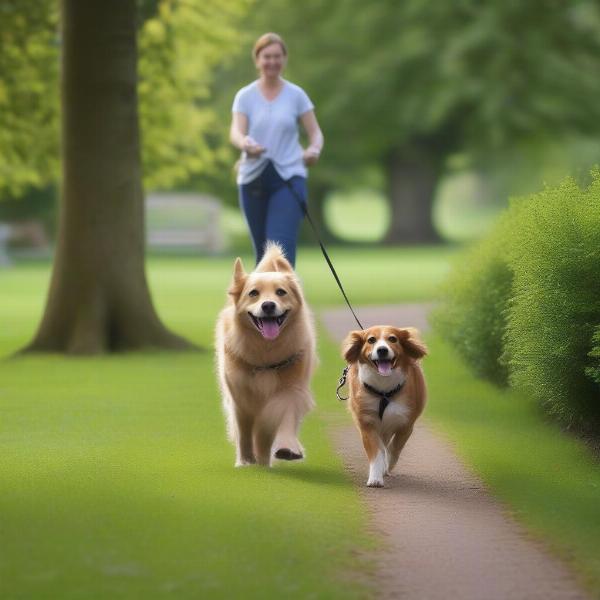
[342,325,427,487]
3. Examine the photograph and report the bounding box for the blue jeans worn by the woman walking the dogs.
[239,162,306,266]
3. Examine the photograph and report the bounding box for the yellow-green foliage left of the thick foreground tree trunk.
[0,0,59,200]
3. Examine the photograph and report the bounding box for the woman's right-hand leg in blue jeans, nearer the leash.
[266,177,306,266]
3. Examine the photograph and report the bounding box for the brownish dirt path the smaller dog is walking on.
[320,305,588,600]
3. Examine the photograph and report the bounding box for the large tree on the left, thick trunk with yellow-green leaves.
[0,0,248,353]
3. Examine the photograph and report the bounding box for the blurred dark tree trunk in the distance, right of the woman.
[385,148,441,244]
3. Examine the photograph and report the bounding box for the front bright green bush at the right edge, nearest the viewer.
[506,172,600,428]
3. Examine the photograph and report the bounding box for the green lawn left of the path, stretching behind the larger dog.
[0,250,445,598]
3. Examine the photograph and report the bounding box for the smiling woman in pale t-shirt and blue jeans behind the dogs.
[230,33,323,265]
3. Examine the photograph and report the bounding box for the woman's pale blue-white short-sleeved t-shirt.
[231,79,314,184]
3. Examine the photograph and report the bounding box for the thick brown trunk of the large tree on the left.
[25,0,191,354]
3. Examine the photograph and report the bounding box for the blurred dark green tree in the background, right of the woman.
[241,0,600,242]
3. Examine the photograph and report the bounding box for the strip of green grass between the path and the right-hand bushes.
[425,338,600,597]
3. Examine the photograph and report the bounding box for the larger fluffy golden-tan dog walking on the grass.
[215,243,317,466]
